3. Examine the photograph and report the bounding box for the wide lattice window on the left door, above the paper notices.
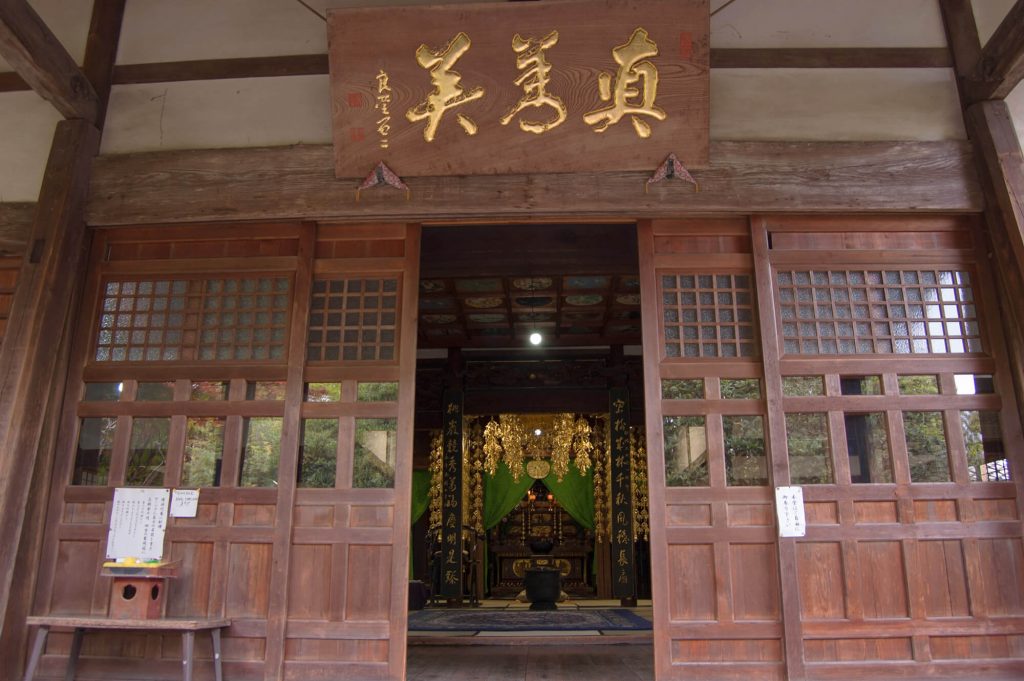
[94,276,291,361]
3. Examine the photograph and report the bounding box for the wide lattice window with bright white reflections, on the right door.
[775,269,983,354]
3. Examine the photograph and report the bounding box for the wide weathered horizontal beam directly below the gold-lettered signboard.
[86,141,984,226]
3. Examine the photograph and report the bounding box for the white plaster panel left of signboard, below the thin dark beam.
[100,76,331,154]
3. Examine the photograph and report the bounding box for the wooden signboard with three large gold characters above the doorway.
[328,0,710,177]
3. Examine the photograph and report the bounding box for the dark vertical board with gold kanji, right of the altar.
[608,388,636,598]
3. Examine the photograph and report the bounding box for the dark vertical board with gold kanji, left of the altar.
[440,390,462,598]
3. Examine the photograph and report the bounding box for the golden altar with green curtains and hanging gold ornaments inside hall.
[405,406,649,606]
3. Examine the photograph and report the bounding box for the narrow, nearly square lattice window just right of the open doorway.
[662,273,760,358]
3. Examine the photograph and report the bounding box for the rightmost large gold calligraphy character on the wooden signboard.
[583,28,667,138]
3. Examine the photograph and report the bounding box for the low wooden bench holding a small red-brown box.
[25,615,231,681]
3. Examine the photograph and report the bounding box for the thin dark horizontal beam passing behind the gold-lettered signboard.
[0,47,952,92]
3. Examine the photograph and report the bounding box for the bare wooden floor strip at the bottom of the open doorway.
[407,644,654,681]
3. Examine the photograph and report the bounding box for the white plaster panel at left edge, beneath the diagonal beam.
[0,91,60,202]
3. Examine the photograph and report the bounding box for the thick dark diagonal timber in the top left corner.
[0,0,99,123]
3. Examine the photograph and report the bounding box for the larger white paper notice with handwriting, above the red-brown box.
[106,487,171,560]
